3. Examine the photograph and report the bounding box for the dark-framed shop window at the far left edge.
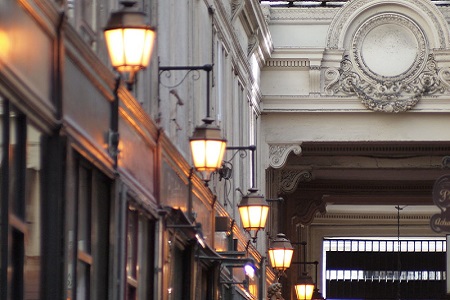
[0,97,41,300]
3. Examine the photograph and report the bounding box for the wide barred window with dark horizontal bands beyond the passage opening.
[324,238,446,300]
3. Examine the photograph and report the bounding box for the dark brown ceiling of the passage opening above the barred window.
[277,142,450,223]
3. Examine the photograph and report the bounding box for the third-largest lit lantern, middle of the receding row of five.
[238,189,269,231]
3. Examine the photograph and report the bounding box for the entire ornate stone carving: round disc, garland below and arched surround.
[323,7,450,113]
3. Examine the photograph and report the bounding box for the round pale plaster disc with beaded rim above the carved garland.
[352,13,427,82]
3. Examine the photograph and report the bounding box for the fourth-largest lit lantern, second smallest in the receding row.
[267,233,294,271]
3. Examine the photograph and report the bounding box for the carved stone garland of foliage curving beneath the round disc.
[325,54,450,113]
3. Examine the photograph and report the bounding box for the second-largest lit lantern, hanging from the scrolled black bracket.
[190,120,227,181]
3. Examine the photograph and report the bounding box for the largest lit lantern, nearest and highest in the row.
[104,1,156,88]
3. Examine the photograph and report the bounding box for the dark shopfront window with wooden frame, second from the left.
[76,160,111,300]
